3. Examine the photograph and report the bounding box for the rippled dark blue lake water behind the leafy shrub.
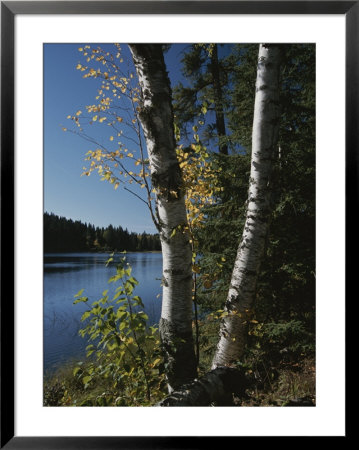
[44,253,162,373]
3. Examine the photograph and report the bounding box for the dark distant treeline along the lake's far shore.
[44,212,161,253]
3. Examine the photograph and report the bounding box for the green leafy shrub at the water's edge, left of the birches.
[63,258,165,406]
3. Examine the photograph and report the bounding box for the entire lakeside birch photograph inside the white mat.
[43,41,317,407]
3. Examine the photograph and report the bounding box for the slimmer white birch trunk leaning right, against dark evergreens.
[212,44,281,368]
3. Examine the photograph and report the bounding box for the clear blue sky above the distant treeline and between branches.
[44,43,190,232]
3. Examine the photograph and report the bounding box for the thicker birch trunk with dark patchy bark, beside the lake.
[130,44,196,392]
